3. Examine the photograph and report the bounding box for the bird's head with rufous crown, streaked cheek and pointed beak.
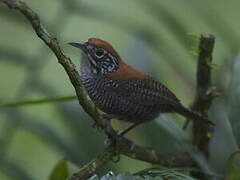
[68,38,120,75]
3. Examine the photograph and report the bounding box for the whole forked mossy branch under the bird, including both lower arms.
[0,0,208,179]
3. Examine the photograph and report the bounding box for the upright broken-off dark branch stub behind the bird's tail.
[184,34,219,157]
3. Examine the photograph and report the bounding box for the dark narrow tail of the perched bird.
[177,106,215,126]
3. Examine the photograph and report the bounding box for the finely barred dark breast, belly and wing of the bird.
[81,57,180,122]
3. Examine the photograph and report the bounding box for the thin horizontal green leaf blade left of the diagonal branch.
[0,96,76,107]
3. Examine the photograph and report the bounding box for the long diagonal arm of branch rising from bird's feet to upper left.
[0,0,104,126]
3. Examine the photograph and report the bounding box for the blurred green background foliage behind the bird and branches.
[0,0,240,180]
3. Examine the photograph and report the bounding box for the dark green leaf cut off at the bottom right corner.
[226,151,240,180]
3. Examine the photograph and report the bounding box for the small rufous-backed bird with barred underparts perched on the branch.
[68,38,214,135]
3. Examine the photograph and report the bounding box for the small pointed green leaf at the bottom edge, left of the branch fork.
[49,159,69,180]
